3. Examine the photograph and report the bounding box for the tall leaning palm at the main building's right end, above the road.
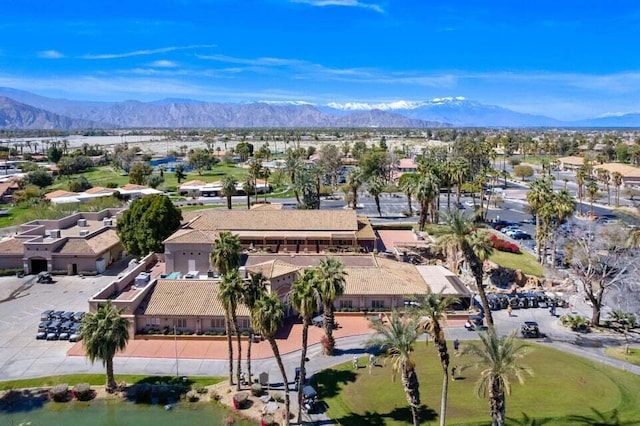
[440,210,493,327]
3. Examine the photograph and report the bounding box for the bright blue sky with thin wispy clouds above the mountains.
[0,0,640,119]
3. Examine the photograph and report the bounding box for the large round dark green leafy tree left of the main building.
[116,194,182,256]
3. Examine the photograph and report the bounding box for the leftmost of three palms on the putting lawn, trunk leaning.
[367,312,421,425]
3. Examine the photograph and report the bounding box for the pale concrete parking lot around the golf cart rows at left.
[0,271,117,379]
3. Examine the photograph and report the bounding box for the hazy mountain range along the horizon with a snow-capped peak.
[0,88,640,130]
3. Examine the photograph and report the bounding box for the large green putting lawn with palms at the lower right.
[313,341,640,426]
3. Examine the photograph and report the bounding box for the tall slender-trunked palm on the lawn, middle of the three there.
[420,293,457,426]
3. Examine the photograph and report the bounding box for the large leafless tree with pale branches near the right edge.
[566,226,638,326]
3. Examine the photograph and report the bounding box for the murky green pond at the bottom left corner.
[0,400,255,426]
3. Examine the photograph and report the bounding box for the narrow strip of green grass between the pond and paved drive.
[0,374,224,390]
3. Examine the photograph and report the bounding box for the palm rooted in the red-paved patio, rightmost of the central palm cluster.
[317,257,347,355]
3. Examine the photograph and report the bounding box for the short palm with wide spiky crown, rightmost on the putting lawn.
[463,328,533,426]
